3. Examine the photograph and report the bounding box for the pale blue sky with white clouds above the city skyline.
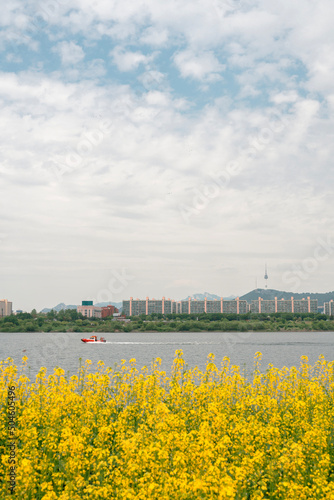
[0,0,334,311]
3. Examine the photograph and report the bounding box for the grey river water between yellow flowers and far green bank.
[0,332,334,378]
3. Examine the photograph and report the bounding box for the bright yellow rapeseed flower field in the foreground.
[0,351,334,500]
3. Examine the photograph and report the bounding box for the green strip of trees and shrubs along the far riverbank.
[0,309,334,333]
